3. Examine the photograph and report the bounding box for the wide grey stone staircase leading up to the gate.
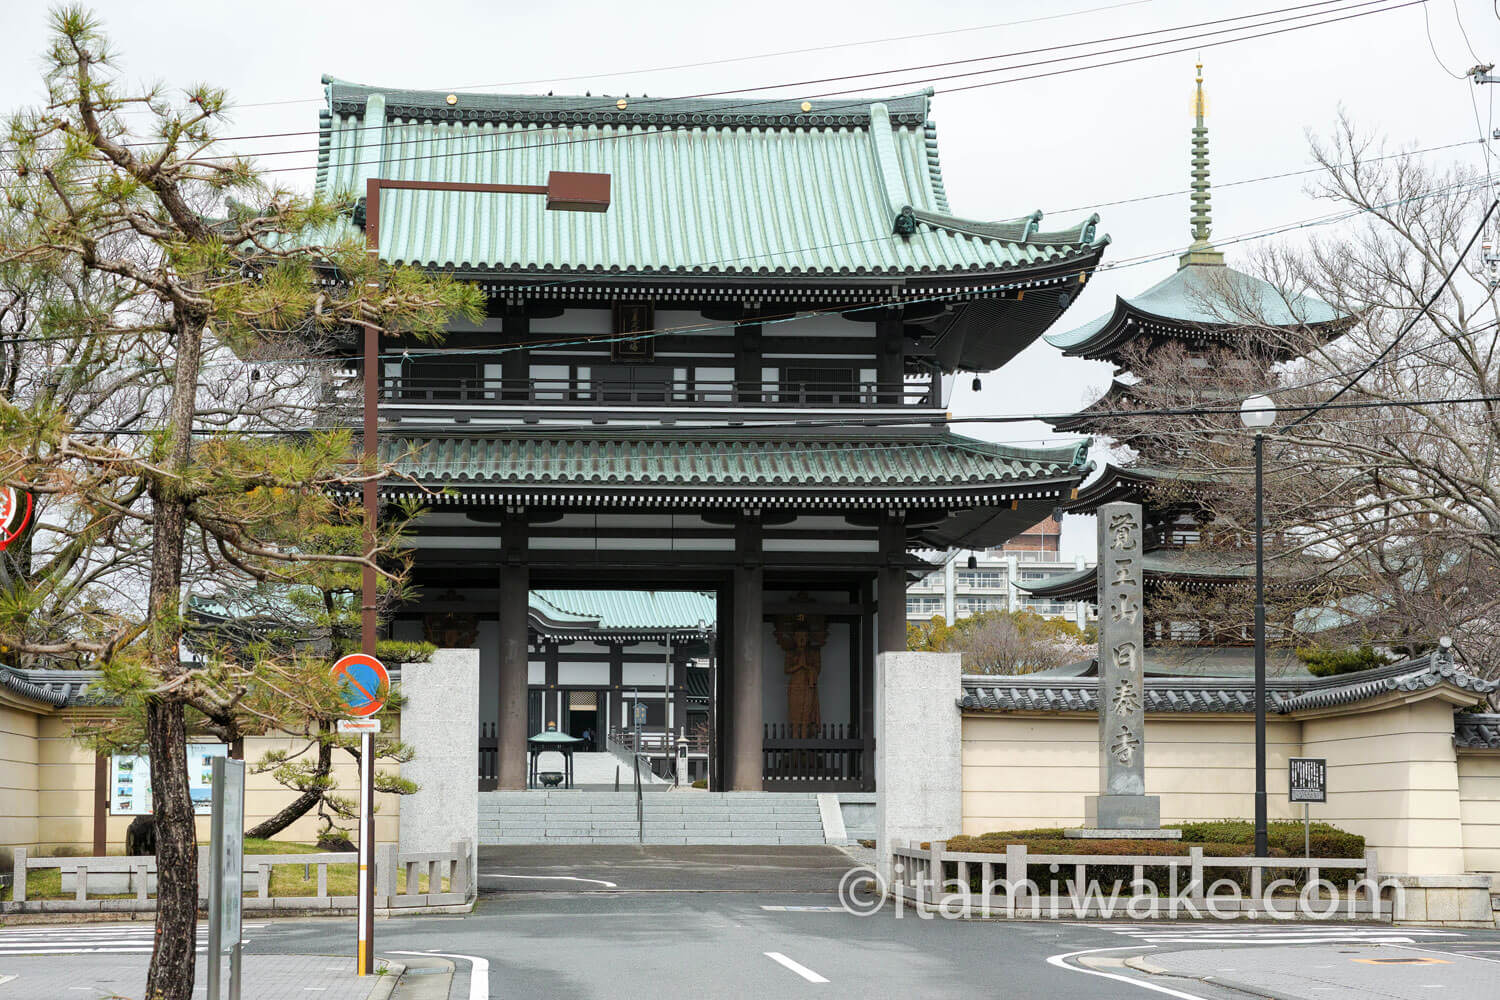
[479,790,827,846]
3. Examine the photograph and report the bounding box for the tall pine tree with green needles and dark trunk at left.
[0,7,479,1000]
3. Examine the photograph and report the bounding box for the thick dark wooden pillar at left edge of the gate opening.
[497,508,531,790]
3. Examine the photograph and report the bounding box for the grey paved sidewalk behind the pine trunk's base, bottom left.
[0,954,404,1000]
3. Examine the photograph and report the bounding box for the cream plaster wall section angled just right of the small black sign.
[1302,699,1464,876]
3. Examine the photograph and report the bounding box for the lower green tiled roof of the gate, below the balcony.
[380,430,1089,493]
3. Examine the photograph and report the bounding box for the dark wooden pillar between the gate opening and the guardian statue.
[729,511,765,792]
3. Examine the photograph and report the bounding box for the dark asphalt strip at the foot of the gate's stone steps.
[479,844,855,892]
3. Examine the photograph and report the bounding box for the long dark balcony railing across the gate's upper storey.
[380,376,938,406]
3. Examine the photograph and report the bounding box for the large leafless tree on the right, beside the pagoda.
[1119,120,1500,676]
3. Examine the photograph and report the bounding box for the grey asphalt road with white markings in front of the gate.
[0,849,1500,1000]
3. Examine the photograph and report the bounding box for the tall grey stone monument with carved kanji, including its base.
[1068,504,1181,837]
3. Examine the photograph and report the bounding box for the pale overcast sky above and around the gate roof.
[0,0,1500,563]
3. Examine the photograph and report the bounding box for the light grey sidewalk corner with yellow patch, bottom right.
[1128,943,1500,1000]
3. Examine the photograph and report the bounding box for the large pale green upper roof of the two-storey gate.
[318,78,1109,277]
